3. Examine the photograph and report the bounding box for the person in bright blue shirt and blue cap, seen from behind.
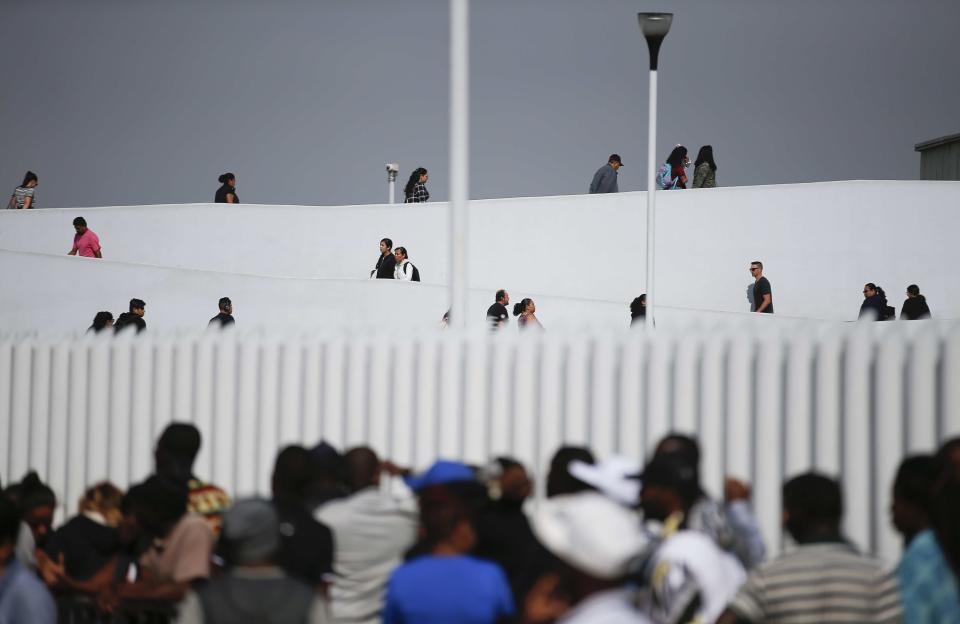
[383,467,515,624]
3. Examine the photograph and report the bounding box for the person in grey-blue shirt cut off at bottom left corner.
[0,496,57,624]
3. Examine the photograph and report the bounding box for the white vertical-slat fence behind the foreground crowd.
[0,323,960,560]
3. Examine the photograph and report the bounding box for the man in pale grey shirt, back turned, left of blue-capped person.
[316,446,418,624]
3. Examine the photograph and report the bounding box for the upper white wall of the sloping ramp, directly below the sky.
[0,182,960,322]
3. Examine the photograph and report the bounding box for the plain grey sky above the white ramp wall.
[0,0,960,207]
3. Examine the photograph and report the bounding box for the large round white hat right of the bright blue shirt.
[532,492,648,580]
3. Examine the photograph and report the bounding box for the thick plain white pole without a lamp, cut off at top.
[449,0,470,328]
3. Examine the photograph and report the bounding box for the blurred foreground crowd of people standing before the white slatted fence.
[0,422,960,624]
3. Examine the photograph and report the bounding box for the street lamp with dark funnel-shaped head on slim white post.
[637,13,673,331]
